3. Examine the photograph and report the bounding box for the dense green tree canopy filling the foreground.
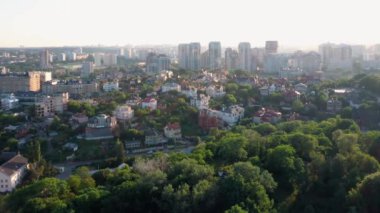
[1,117,380,212]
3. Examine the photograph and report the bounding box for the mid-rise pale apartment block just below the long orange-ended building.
[35,92,69,117]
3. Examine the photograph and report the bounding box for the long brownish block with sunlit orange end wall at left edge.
[0,72,41,93]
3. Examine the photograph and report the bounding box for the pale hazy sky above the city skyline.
[0,0,380,47]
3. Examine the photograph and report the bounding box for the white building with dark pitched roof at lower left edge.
[0,154,28,193]
